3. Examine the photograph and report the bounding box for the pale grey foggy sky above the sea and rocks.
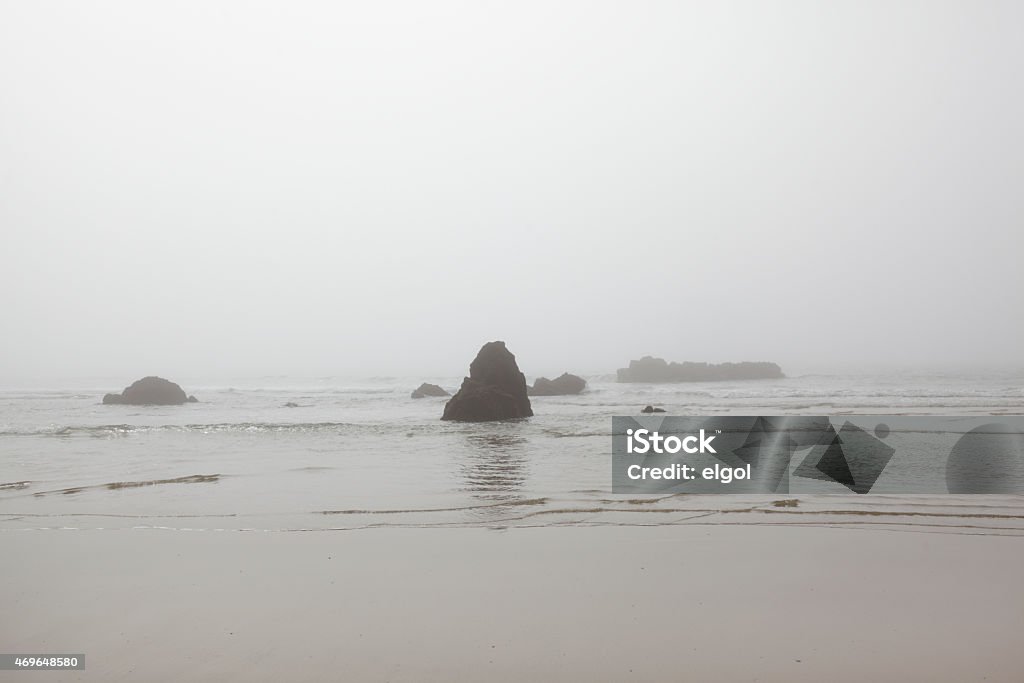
[0,1,1024,384]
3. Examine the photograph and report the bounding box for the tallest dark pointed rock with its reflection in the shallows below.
[441,341,534,422]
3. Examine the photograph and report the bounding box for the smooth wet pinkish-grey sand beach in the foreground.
[0,525,1024,681]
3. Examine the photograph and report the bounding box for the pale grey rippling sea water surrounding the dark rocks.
[0,373,1024,533]
